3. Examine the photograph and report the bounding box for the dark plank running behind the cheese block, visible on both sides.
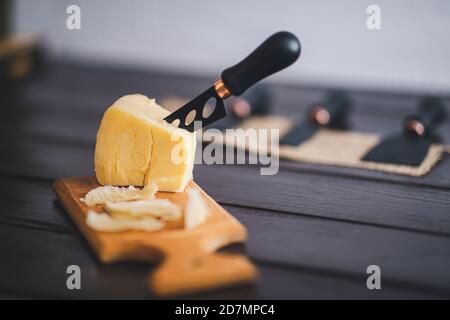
[0,135,450,235]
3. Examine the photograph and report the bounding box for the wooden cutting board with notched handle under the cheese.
[53,177,257,296]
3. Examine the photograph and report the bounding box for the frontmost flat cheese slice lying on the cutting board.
[106,199,181,221]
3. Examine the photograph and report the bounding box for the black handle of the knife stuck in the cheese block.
[221,31,301,96]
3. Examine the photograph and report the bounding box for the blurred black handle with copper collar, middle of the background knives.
[308,92,351,129]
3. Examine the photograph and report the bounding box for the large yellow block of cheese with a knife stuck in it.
[95,94,196,192]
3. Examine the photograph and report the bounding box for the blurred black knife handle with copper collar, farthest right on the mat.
[403,97,447,137]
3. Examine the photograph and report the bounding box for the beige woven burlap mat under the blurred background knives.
[203,116,450,177]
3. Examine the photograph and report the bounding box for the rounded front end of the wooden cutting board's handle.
[150,246,257,296]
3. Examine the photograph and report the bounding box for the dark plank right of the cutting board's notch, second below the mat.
[230,206,450,294]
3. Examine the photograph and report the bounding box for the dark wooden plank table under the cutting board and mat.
[0,61,450,299]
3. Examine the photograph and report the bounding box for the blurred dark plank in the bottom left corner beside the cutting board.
[0,225,153,299]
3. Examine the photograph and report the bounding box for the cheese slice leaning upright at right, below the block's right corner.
[184,188,209,229]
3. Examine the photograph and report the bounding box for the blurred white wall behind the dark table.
[9,0,450,94]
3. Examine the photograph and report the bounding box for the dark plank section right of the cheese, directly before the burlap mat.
[194,165,450,236]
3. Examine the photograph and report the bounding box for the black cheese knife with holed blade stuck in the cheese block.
[165,31,301,132]
